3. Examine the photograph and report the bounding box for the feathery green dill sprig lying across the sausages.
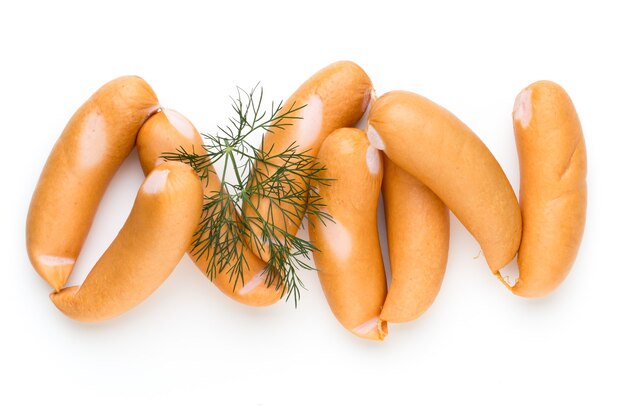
[163,84,332,306]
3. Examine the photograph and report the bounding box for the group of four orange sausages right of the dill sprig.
[310,82,586,340]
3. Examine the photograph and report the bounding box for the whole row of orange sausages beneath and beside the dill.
[26,62,587,340]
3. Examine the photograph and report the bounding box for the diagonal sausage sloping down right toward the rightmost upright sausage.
[368,91,522,274]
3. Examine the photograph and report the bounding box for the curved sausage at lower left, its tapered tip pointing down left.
[50,162,202,321]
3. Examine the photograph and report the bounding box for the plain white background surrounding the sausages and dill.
[0,1,626,416]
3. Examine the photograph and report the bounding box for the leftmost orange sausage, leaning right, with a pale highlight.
[26,76,159,291]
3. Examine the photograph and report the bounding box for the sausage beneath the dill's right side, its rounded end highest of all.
[244,61,372,261]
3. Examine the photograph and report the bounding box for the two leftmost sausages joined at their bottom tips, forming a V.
[26,77,202,321]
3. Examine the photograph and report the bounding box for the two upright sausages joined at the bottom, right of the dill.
[309,128,449,340]
